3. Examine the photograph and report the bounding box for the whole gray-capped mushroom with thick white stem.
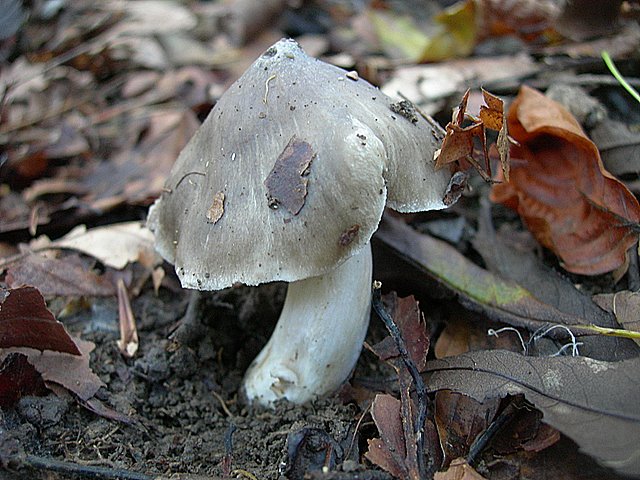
[148,39,450,405]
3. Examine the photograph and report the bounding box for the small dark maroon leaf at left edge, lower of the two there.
[0,353,48,408]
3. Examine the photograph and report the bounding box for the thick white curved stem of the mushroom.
[244,243,372,406]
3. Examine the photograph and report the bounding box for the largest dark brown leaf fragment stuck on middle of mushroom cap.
[264,135,316,215]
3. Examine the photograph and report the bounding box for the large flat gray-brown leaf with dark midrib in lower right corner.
[426,350,640,475]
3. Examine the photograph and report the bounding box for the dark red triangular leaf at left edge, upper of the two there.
[0,287,80,355]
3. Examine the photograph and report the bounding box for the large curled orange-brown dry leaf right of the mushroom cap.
[491,86,640,275]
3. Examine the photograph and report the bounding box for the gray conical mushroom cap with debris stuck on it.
[148,40,449,290]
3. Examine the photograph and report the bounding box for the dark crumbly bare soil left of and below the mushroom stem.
[0,285,382,479]
